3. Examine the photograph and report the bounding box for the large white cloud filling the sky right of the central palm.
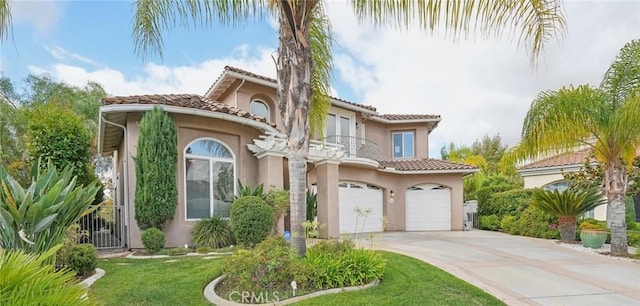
[328,1,640,157]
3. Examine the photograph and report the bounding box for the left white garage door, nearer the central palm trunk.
[339,182,382,234]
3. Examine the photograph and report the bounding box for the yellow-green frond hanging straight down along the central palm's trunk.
[309,4,333,138]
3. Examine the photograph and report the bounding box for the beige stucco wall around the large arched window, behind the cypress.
[127,114,260,248]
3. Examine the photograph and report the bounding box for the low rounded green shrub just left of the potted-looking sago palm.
[512,206,560,239]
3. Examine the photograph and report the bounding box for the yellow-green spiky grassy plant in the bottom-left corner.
[0,246,96,306]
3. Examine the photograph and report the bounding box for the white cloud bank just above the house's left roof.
[29,46,275,95]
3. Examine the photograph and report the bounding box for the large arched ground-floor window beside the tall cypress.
[184,138,236,220]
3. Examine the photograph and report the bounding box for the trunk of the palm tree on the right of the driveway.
[605,158,629,256]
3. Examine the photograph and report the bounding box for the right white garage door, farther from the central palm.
[406,184,451,231]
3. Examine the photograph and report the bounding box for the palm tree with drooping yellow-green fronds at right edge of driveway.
[512,40,640,256]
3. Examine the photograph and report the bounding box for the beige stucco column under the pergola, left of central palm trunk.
[258,152,284,234]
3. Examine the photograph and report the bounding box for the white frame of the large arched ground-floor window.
[182,137,238,221]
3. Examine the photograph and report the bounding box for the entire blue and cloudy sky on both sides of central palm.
[0,0,640,157]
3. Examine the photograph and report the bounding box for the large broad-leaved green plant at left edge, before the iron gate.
[0,162,100,253]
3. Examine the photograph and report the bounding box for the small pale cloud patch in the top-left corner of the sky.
[9,0,64,34]
